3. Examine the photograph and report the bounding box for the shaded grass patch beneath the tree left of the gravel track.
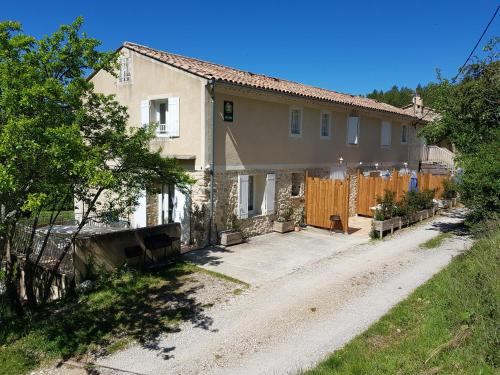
[0,263,241,374]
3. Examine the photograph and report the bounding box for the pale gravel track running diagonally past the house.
[94,211,471,374]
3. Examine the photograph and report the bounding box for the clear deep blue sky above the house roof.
[0,0,500,94]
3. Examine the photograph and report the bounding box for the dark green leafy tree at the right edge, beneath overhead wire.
[422,38,500,222]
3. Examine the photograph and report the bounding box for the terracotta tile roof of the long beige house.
[123,42,415,118]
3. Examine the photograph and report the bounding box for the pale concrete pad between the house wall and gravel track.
[184,226,369,285]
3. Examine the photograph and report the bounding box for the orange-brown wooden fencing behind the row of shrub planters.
[357,170,449,216]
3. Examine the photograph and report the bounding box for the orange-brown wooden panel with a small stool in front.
[305,177,349,234]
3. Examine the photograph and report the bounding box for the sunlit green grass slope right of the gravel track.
[306,229,500,375]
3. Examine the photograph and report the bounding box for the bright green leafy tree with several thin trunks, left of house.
[0,18,192,313]
